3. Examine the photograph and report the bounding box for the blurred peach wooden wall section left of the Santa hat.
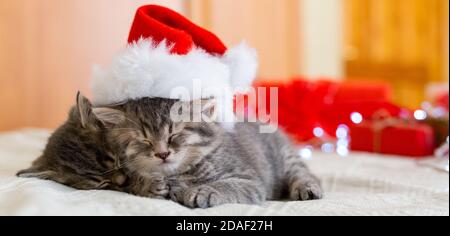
[0,0,184,130]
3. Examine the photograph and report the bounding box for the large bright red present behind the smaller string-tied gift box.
[246,77,399,142]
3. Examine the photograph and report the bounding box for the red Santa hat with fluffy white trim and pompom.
[91,5,257,124]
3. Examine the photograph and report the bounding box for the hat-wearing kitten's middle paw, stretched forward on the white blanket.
[183,185,223,208]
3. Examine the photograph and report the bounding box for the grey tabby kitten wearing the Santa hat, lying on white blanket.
[96,98,322,208]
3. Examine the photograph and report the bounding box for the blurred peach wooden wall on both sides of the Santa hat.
[0,0,302,130]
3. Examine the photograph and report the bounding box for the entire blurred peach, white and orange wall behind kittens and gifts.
[0,0,449,130]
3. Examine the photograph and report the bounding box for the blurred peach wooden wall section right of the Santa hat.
[186,0,303,80]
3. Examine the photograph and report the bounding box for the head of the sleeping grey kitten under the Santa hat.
[100,98,222,175]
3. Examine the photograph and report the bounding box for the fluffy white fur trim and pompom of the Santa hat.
[91,39,257,122]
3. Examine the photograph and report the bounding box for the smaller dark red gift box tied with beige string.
[349,111,435,157]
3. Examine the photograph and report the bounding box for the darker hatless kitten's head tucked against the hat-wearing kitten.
[17,94,126,190]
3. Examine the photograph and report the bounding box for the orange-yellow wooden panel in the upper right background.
[344,0,449,107]
